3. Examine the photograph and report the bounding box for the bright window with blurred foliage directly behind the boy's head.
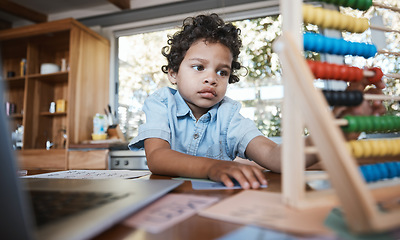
[118,16,283,139]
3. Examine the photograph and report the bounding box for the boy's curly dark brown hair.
[161,13,242,83]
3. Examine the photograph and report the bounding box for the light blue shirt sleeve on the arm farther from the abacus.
[128,92,171,150]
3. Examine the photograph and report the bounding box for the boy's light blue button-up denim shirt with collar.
[129,87,262,160]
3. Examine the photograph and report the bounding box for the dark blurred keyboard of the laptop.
[29,190,129,227]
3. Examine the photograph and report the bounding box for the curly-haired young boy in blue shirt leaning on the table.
[129,14,382,189]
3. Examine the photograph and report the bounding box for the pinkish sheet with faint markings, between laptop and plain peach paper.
[124,193,218,233]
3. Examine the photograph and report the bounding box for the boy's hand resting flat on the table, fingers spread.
[208,160,267,189]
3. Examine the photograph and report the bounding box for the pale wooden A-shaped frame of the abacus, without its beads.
[274,0,400,233]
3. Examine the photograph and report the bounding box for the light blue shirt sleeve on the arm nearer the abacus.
[227,103,263,159]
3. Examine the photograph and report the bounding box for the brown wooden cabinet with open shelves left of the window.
[0,19,110,170]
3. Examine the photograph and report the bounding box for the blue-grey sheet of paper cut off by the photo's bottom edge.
[217,225,337,240]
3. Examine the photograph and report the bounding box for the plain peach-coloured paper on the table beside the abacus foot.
[199,190,332,235]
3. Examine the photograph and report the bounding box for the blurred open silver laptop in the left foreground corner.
[0,80,183,240]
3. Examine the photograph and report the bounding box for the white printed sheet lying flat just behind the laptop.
[23,170,151,179]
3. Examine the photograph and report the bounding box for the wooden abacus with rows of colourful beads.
[273,0,400,233]
